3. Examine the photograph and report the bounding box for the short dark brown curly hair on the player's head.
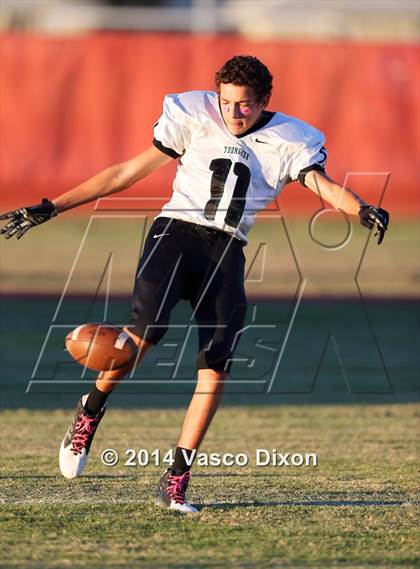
[216,55,273,103]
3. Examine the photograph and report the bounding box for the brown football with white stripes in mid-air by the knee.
[66,324,137,371]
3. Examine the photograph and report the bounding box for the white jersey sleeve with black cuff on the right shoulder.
[289,129,327,185]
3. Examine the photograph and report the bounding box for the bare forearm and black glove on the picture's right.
[305,166,389,245]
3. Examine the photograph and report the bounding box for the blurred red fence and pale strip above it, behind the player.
[0,0,420,216]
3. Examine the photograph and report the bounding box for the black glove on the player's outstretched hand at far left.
[0,198,58,239]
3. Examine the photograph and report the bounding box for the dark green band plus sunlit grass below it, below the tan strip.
[0,296,419,569]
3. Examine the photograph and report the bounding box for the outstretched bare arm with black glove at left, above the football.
[0,146,171,239]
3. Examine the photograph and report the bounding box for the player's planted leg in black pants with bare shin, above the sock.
[174,236,247,454]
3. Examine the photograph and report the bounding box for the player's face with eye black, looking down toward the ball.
[219,83,267,136]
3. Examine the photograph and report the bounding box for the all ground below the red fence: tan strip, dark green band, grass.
[0,217,420,569]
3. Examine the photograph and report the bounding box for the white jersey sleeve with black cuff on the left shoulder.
[153,95,191,158]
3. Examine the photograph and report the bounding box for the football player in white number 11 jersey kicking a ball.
[1,56,389,513]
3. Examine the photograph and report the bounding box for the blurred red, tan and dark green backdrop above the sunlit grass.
[0,0,420,406]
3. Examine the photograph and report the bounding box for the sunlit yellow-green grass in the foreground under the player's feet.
[1,404,419,569]
